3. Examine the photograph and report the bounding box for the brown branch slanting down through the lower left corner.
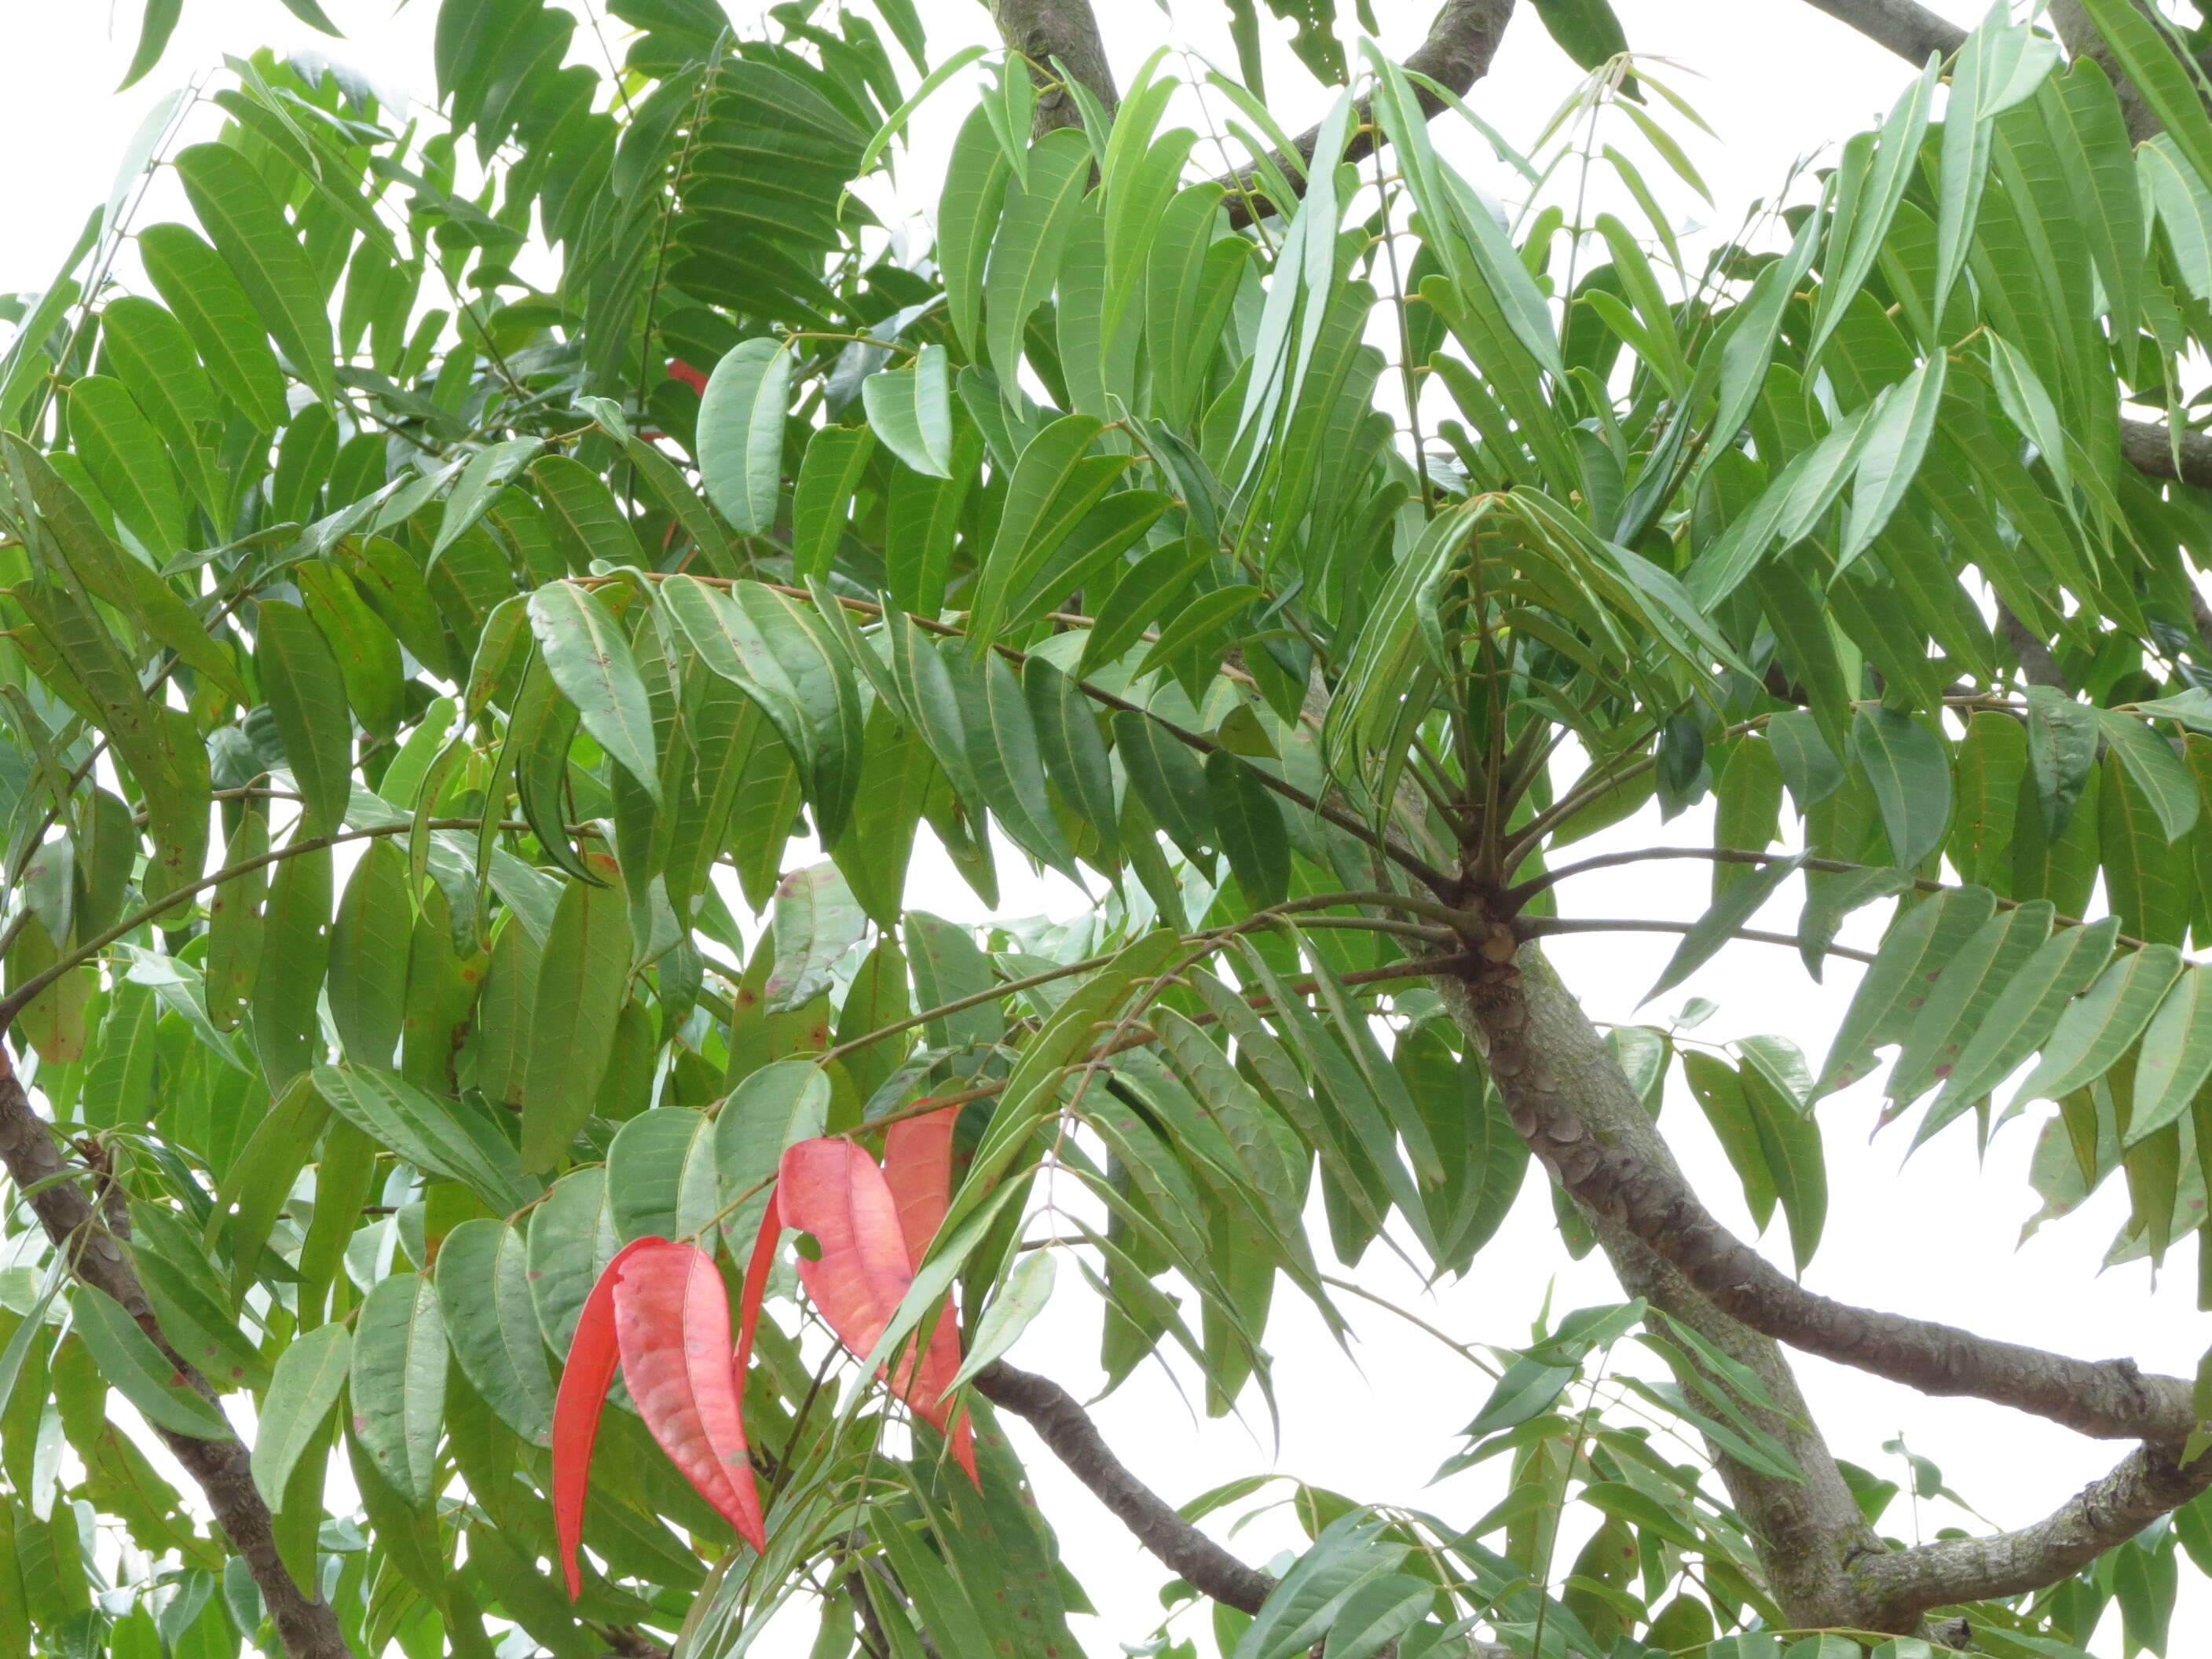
[0,1046,347,1659]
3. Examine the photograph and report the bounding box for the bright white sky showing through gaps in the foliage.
[0,0,2212,1654]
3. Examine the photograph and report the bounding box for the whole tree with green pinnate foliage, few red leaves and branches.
[0,0,2212,1659]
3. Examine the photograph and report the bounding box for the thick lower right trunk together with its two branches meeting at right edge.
[1436,944,2212,1632]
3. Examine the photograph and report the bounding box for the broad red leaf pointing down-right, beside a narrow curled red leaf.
[615,1239,767,1551]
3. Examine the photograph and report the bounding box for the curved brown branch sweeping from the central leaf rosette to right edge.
[1467,951,2196,1445]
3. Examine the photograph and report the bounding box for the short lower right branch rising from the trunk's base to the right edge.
[1860,1447,2212,1619]
